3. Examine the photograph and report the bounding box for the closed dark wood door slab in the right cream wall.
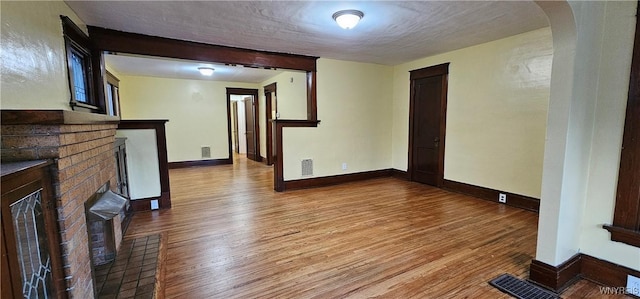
[409,63,447,187]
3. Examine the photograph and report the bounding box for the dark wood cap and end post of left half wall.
[118,119,171,211]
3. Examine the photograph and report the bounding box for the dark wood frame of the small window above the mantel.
[60,16,104,113]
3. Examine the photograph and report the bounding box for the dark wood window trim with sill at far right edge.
[605,2,640,247]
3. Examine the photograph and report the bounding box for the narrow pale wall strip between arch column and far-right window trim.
[579,2,640,271]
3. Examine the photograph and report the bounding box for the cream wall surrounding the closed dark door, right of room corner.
[392,28,552,198]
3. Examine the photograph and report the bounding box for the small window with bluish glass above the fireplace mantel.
[61,16,101,112]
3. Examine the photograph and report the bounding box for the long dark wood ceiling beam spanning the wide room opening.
[87,26,318,71]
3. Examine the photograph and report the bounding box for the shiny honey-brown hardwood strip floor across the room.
[127,157,632,298]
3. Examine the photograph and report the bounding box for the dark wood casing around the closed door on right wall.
[407,62,449,188]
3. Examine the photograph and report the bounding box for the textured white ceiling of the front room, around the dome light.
[67,1,548,81]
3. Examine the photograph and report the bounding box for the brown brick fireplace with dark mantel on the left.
[1,110,122,298]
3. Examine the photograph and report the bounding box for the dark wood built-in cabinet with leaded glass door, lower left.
[0,161,66,298]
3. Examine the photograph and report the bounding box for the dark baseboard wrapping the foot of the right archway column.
[529,254,582,292]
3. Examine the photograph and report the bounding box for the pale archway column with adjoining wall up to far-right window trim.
[536,1,640,270]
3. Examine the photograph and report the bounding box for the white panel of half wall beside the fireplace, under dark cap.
[116,129,162,200]
